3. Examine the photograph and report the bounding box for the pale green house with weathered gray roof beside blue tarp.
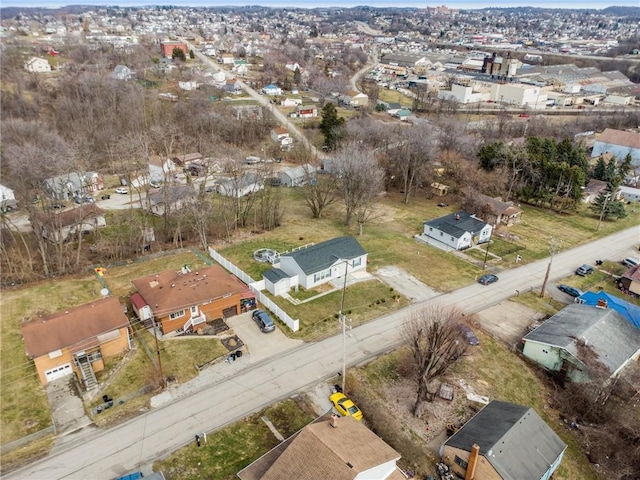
[522,304,640,382]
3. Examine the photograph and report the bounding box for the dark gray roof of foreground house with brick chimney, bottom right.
[445,400,566,480]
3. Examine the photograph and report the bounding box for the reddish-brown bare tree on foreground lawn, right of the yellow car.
[403,304,467,416]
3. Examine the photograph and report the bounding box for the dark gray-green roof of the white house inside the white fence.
[280,237,367,275]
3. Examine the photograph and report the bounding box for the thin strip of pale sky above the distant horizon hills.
[5,0,640,9]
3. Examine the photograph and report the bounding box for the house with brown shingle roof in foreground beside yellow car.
[237,416,406,480]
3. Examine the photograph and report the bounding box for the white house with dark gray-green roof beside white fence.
[263,237,367,295]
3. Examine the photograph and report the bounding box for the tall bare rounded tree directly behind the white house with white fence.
[335,143,384,233]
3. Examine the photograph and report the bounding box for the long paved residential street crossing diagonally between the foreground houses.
[3,227,640,479]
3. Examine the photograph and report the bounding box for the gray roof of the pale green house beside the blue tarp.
[524,304,640,372]
